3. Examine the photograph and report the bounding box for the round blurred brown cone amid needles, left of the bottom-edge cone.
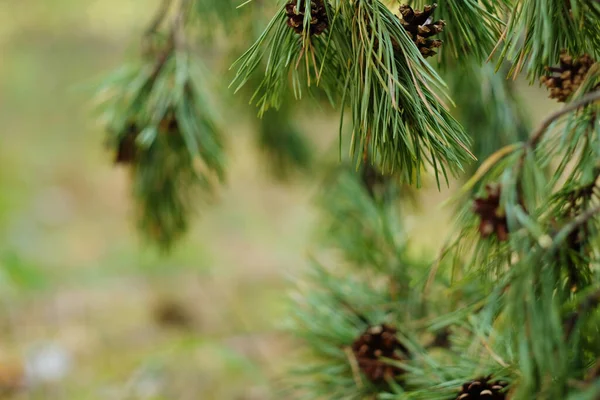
[352,324,408,383]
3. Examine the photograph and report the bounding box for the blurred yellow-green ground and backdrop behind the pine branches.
[0,0,556,400]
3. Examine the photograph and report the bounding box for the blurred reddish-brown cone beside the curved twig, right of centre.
[473,184,508,242]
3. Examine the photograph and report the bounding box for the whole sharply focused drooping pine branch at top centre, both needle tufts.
[234,0,471,182]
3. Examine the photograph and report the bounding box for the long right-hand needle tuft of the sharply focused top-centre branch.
[340,1,472,185]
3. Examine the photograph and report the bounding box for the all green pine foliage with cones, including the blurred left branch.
[95,0,600,400]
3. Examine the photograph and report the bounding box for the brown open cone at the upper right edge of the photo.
[540,50,594,103]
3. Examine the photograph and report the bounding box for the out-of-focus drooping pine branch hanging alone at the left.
[98,1,224,249]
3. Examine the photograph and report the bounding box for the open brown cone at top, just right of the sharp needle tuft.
[400,4,446,58]
